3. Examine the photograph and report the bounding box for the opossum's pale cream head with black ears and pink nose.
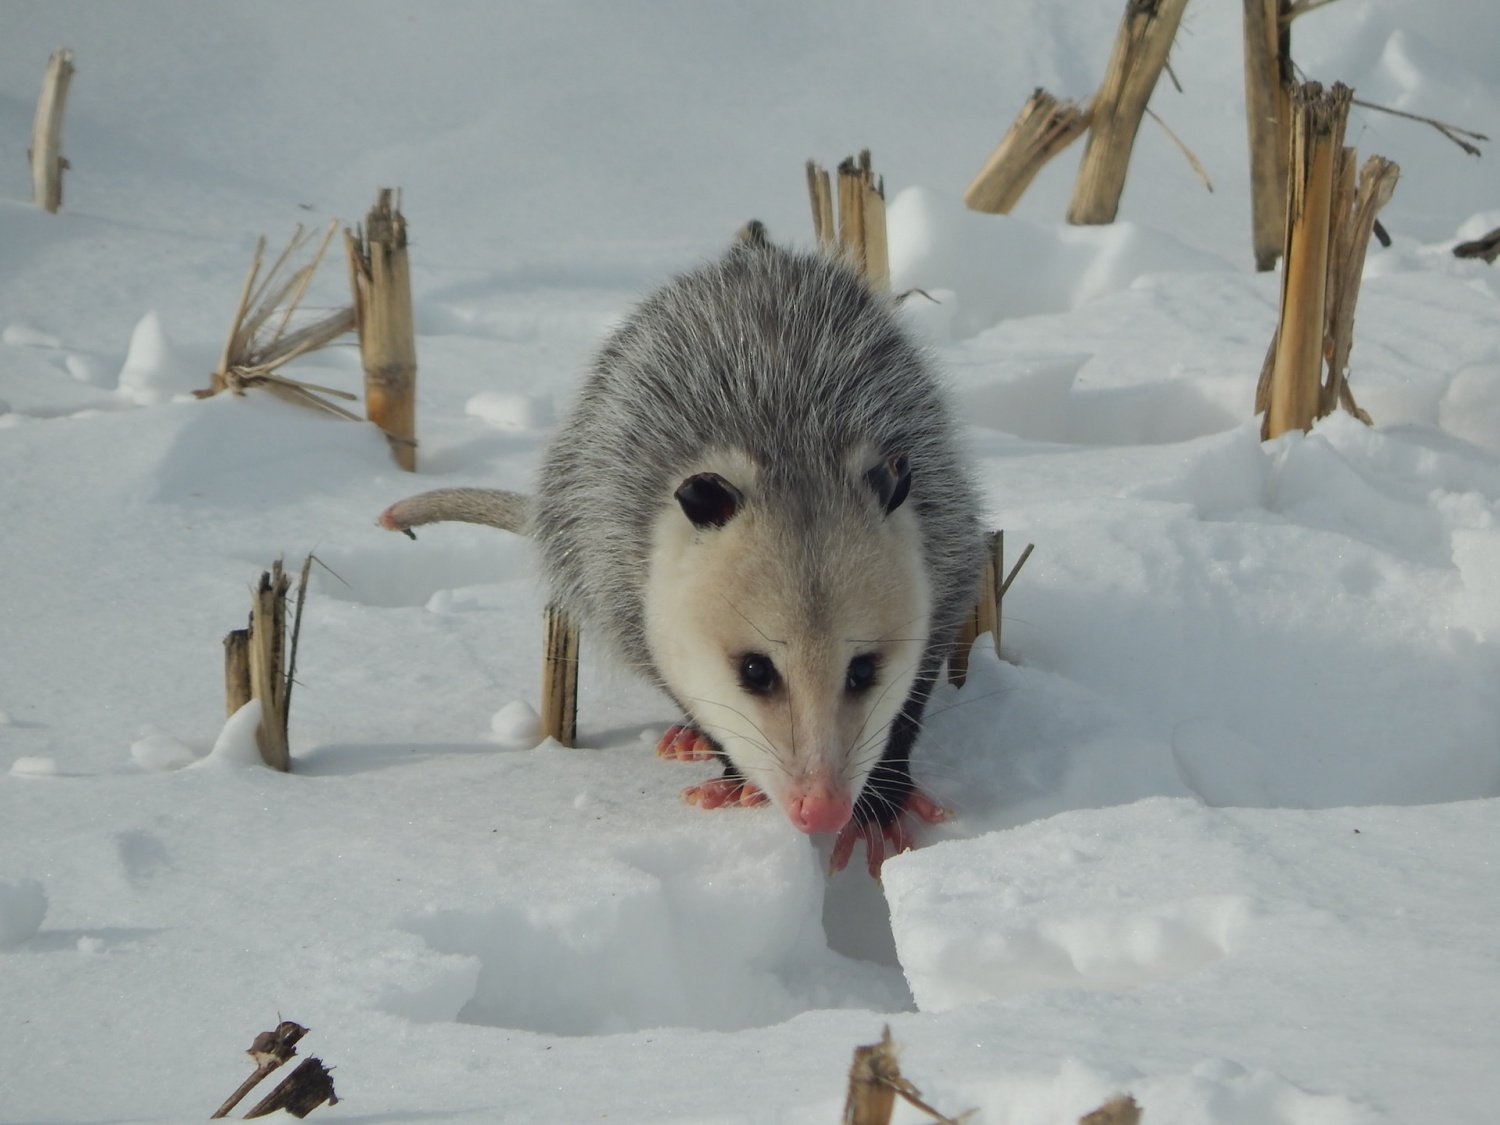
[645,450,932,833]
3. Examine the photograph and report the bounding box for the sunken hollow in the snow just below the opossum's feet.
[383,834,912,1035]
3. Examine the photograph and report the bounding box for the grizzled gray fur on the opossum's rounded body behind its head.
[531,240,983,687]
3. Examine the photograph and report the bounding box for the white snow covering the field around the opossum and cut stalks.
[0,0,1500,1125]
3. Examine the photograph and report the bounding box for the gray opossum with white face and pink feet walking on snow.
[381,224,984,873]
